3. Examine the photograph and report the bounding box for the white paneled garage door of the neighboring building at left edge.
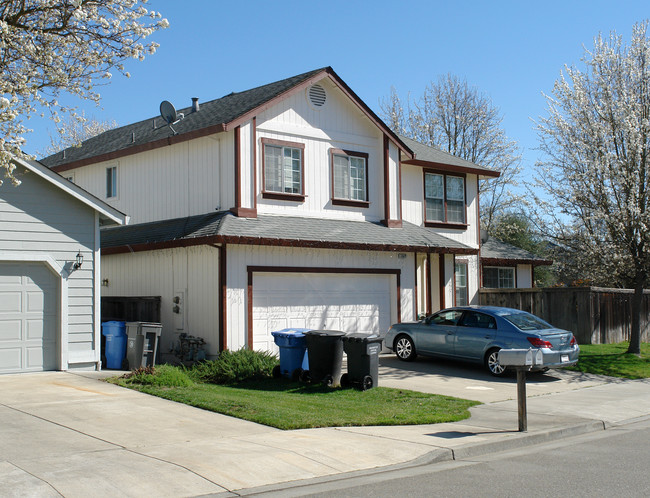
[0,262,58,373]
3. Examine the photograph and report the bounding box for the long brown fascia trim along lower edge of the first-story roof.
[101,235,478,256]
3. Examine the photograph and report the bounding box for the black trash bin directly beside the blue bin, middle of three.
[302,330,345,386]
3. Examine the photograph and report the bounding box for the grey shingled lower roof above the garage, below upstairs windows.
[101,211,478,254]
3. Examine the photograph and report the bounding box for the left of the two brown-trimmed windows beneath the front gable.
[262,138,305,201]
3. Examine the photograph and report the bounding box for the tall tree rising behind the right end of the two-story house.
[381,74,521,232]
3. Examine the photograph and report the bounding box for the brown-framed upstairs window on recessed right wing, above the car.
[424,171,466,224]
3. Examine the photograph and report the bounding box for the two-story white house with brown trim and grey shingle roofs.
[44,67,498,355]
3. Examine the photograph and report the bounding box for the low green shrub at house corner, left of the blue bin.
[191,349,278,384]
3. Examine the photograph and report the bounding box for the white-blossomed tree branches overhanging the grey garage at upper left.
[0,0,169,185]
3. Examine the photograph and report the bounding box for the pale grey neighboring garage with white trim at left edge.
[0,159,127,373]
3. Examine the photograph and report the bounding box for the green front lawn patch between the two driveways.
[110,367,479,429]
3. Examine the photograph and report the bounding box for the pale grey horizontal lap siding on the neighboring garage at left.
[0,163,96,367]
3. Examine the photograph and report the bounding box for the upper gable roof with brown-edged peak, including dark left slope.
[41,66,413,171]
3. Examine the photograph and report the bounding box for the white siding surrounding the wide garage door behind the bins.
[227,245,415,350]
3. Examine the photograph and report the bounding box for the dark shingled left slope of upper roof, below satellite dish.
[41,68,330,168]
